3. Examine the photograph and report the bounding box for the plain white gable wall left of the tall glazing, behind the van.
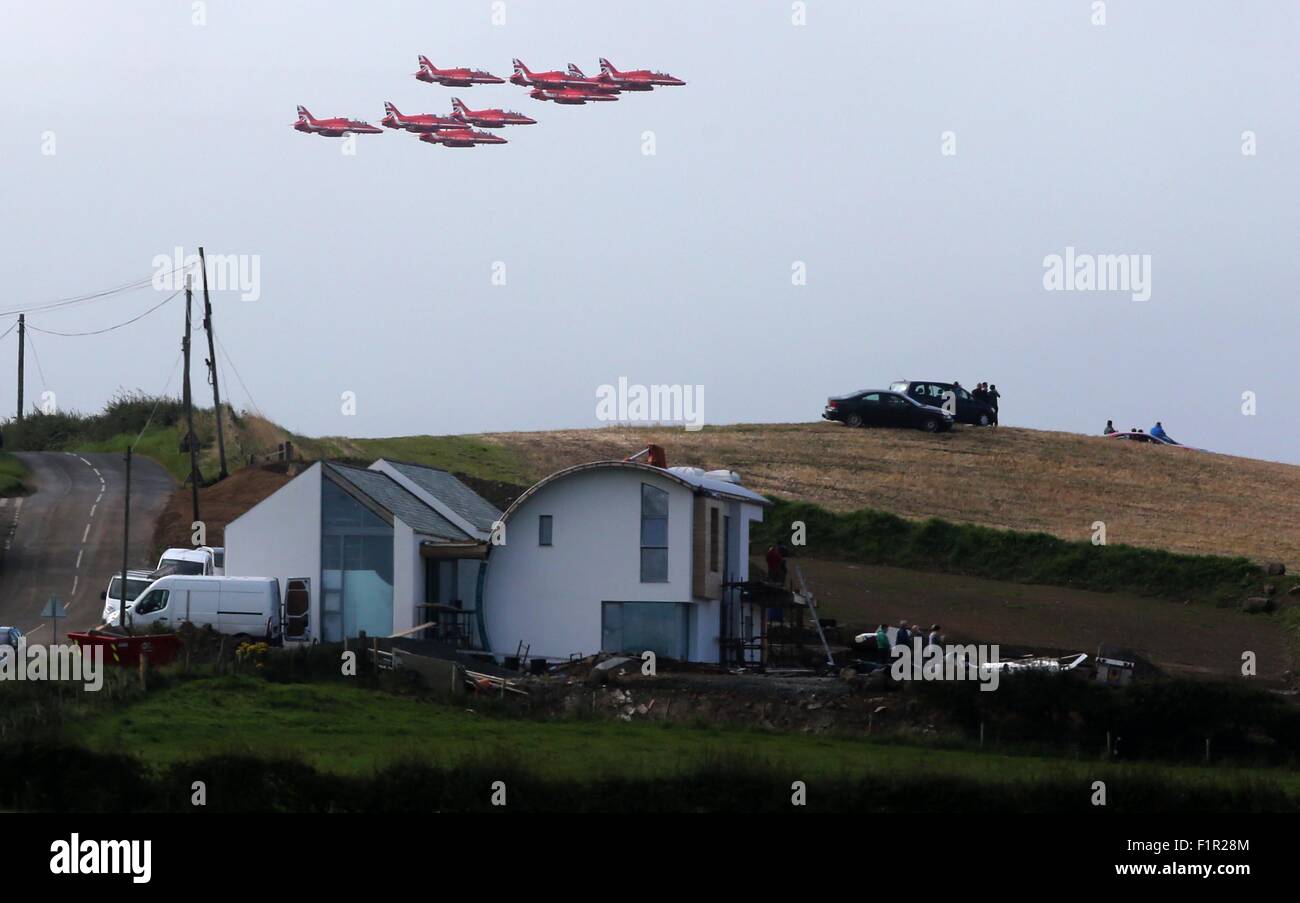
[225,464,321,637]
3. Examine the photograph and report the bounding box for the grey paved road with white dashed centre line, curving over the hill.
[0,452,176,643]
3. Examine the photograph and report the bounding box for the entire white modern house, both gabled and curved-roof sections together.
[225,460,768,661]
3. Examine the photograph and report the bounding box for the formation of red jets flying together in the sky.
[293,56,685,147]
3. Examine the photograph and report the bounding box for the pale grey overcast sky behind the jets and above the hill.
[0,0,1300,463]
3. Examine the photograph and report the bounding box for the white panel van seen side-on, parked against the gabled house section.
[130,574,281,643]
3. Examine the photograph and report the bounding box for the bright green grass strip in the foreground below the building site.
[65,676,1300,795]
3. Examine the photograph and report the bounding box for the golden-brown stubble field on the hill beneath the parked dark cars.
[477,424,1300,569]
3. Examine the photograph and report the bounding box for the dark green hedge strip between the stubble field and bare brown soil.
[753,499,1264,603]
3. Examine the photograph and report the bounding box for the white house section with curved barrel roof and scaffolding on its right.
[482,461,770,661]
